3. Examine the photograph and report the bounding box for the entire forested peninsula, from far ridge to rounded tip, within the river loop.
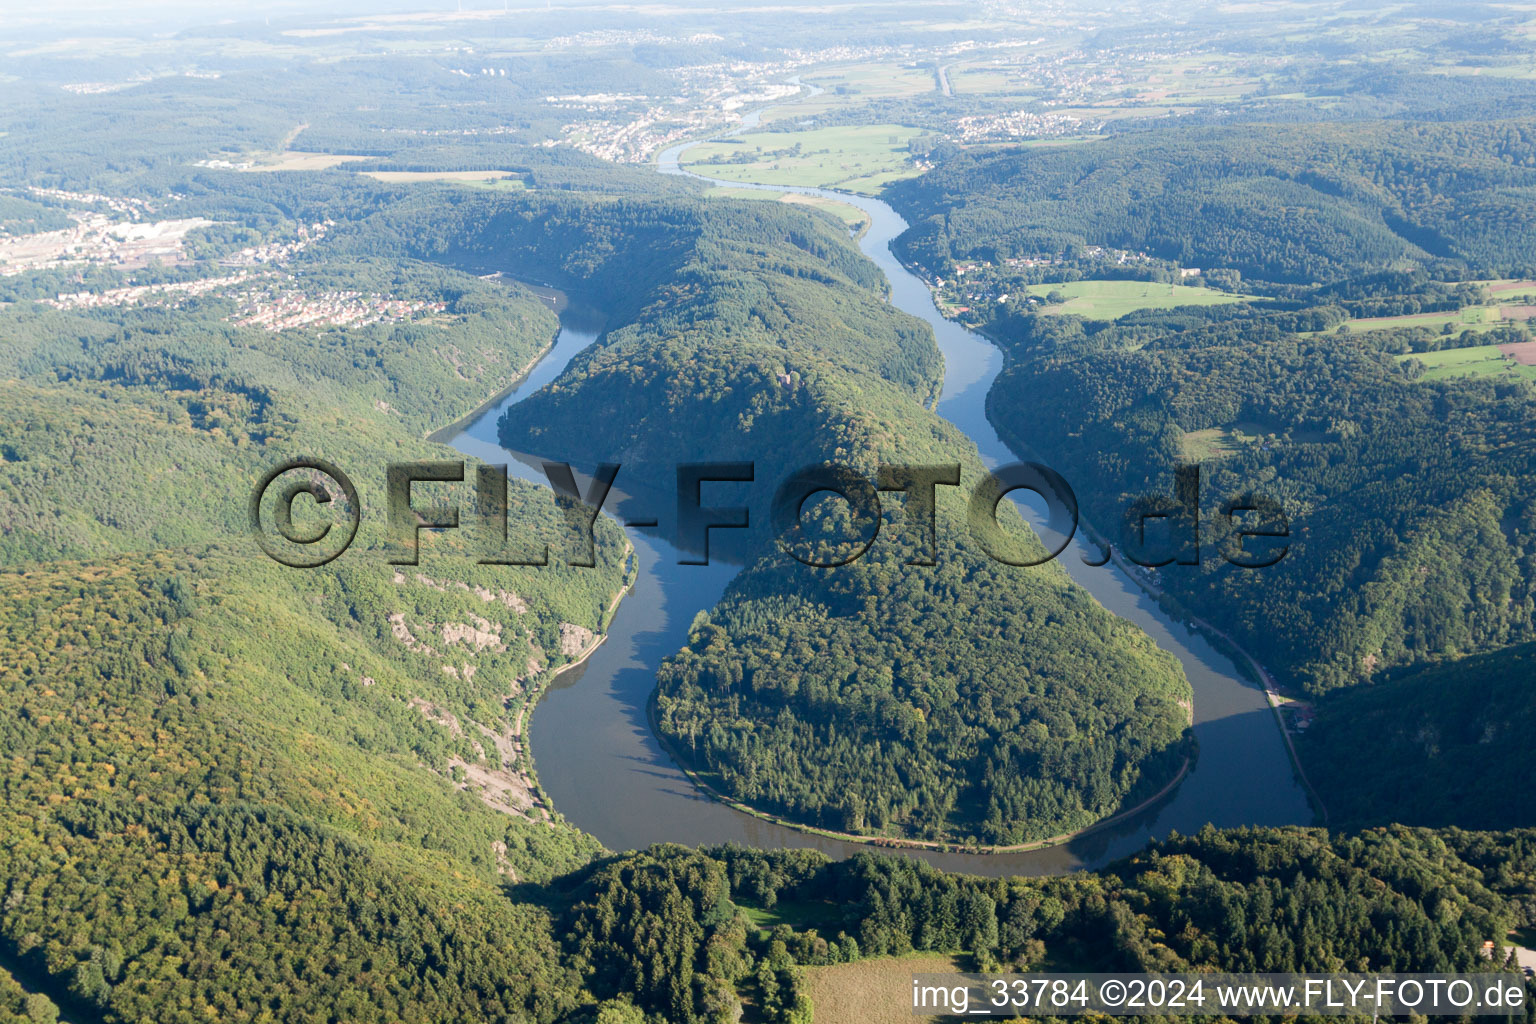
[339,191,1189,843]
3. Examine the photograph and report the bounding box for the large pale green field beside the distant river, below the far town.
[684,124,919,195]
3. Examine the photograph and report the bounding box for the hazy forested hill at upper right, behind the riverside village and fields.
[886,120,1536,284]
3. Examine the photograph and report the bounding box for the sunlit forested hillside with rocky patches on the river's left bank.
[0,231,625,1021]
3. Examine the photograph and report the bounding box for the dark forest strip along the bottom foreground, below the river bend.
[537,827,1536,1024]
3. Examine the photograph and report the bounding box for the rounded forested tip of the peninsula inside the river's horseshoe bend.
[657,534,1193,844]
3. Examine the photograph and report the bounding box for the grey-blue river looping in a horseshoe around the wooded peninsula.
[452,132,1312,875]
